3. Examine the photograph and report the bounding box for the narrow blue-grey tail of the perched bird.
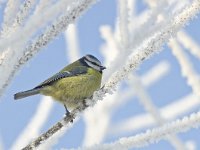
[14,88,40,100]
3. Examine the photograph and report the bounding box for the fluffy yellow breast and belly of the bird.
[41,68,102,108]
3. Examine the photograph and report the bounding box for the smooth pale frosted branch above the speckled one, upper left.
[0,0,72,51]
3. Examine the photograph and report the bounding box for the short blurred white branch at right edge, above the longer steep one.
[177,30,200,59]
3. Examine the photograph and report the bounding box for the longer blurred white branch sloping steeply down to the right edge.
[169,39,200,97]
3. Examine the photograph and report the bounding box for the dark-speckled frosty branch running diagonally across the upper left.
[0,0,95,95]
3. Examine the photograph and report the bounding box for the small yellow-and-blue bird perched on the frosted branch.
[14,54,106,115]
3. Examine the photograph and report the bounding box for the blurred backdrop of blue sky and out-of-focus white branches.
[0,0,200,150]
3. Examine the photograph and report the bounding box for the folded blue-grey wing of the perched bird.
[35,67,87,89]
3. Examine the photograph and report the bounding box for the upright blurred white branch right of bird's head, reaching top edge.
[102,0,130,81]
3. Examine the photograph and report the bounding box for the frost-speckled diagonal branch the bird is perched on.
[21,0,200,149]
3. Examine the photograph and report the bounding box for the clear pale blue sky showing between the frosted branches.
[0,0,200,150]
